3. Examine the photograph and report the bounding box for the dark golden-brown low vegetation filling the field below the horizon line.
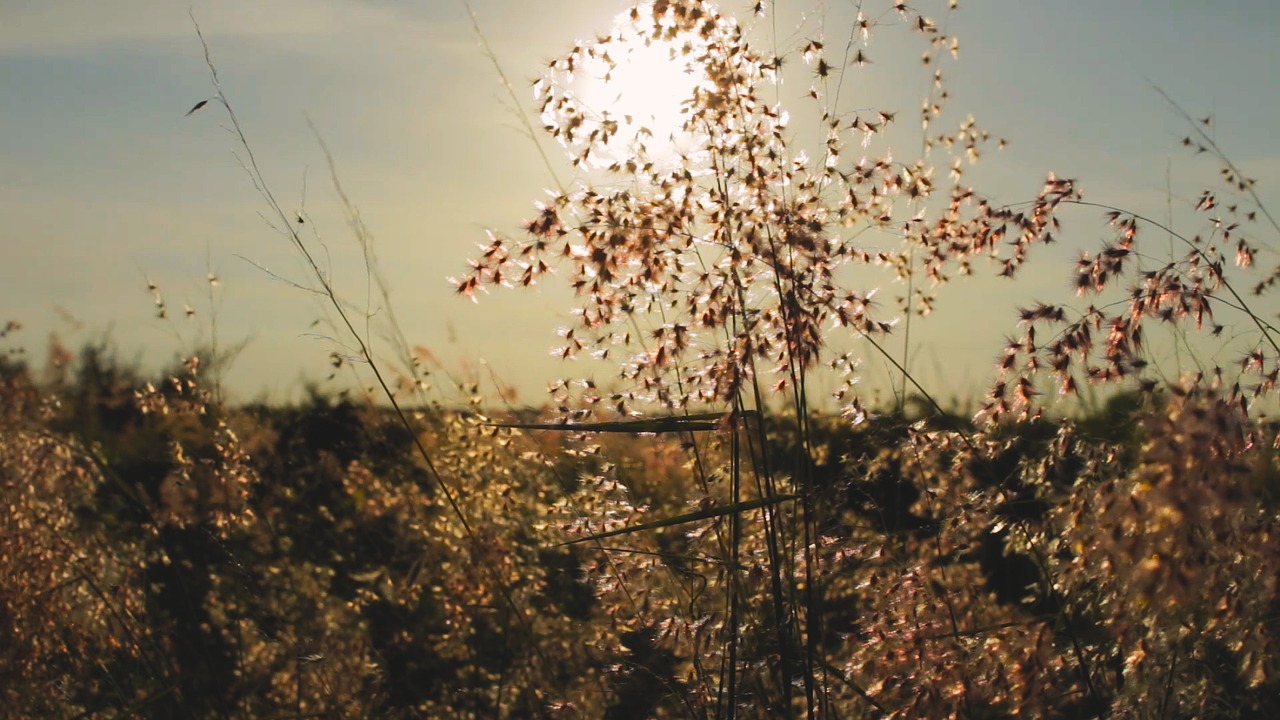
[0,338,1280,717]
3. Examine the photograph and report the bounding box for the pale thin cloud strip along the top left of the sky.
[0,0,435,56]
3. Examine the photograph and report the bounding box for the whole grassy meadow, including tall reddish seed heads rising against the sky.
[0,0,1280,720]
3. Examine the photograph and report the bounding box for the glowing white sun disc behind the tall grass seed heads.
[579,14,705,159]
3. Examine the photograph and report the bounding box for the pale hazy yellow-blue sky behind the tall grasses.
[0,0,1280,404]
